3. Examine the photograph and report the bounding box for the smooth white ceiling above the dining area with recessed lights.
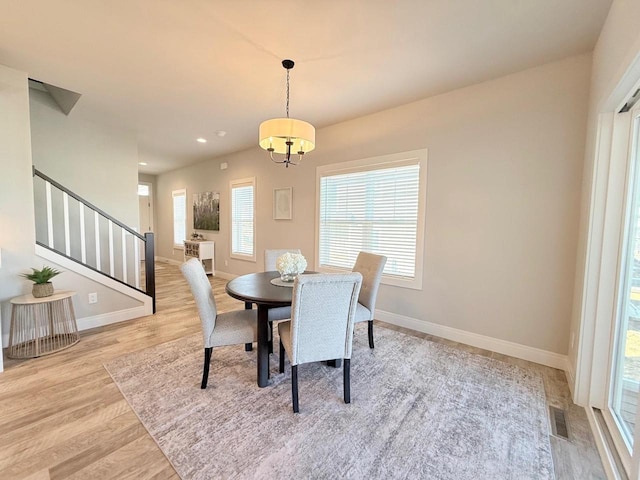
[0,0,611,173]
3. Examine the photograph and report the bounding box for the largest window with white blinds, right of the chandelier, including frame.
[317,150,426,289]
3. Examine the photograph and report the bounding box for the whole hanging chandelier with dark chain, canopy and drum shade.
[260,60,316,168]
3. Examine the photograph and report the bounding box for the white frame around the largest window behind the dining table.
[315,149,427,290]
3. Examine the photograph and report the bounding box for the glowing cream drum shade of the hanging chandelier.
[260,118,316,154]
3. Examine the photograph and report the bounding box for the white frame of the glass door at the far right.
[573,55,640,480]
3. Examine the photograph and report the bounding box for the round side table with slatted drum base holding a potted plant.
[7,290,80,358]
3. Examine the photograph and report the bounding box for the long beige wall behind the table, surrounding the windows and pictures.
[157,55,591,354]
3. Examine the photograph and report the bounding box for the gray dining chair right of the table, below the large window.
[353,252,387,348]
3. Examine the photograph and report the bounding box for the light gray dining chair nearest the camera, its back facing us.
[278,272,362,413]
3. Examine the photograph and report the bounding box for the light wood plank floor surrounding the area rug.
[0,264,605,480]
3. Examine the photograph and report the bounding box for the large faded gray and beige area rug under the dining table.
[105,325,554,480]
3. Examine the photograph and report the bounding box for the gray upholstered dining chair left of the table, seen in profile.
[180,258,258,388]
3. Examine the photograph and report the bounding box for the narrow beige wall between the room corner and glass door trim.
[569,0,640,398]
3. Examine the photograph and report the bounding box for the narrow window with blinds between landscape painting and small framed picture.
[231,177,256,261]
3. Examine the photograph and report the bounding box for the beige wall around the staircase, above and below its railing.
[0,65,140,345]
